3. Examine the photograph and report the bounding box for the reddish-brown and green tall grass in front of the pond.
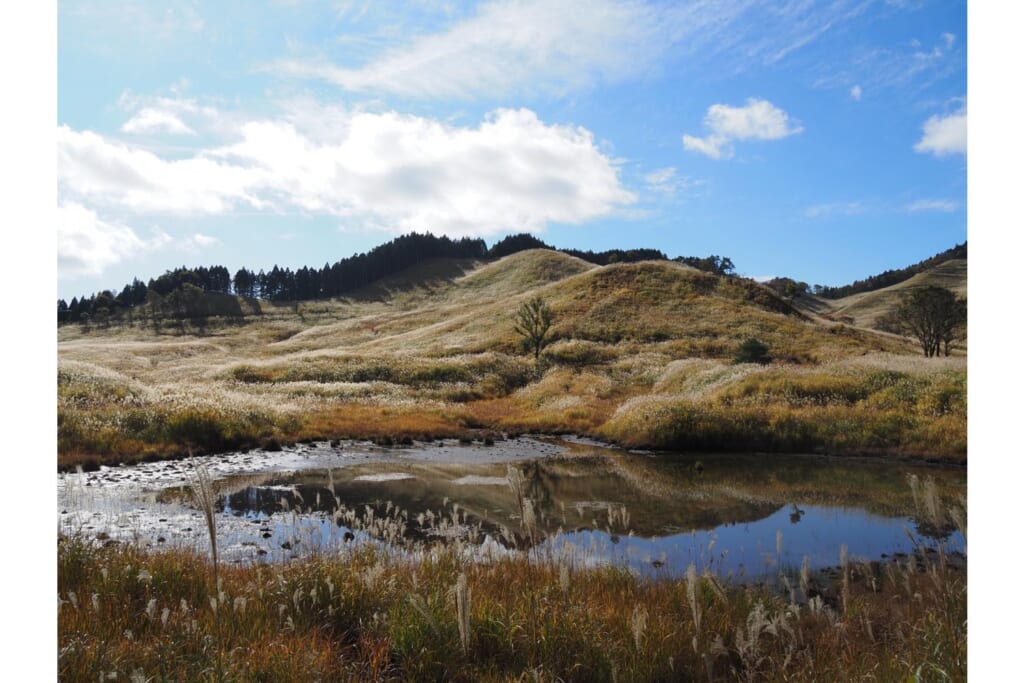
[57,480,967,681]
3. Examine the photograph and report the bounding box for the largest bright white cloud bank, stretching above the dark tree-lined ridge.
[57,109,636,236]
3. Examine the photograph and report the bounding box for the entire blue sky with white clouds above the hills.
[57,0,967,299]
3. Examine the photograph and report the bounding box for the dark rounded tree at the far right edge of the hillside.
[896,285,967,358]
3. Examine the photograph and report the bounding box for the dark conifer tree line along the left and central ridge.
[57,232,734,324]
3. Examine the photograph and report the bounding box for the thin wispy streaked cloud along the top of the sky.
[267,0,864,98]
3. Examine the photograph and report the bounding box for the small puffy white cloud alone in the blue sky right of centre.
[683,97,804,159]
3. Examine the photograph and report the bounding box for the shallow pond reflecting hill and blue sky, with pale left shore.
[58,438,967,580]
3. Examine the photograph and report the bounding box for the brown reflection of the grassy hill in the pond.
[218,444,966,538]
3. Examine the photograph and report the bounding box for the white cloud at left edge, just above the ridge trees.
[56,204,171,278]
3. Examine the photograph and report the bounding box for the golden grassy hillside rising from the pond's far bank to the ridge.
[57,250,966,467]
